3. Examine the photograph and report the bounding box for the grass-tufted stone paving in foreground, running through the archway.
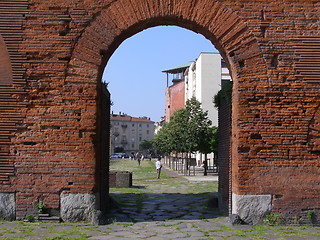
[0,164,320,240]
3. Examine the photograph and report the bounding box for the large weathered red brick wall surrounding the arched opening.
[0,0,320,221]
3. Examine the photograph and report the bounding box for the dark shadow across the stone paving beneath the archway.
[108,192,224,222]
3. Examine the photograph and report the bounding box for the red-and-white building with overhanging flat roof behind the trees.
[163,53,231,165]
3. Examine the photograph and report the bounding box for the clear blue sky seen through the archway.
[102,26,217,122]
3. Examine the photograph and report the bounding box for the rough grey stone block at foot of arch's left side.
[60,193,98,222]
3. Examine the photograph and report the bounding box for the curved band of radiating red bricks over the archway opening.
[67,0,267,85]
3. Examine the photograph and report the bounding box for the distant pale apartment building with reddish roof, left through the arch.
[110,113,155,154]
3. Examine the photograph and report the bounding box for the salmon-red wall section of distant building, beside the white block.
[166,81,185,122]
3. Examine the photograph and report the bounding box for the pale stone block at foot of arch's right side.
[232,193,272,224]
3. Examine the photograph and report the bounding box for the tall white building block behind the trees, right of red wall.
[185,53,231,164]
